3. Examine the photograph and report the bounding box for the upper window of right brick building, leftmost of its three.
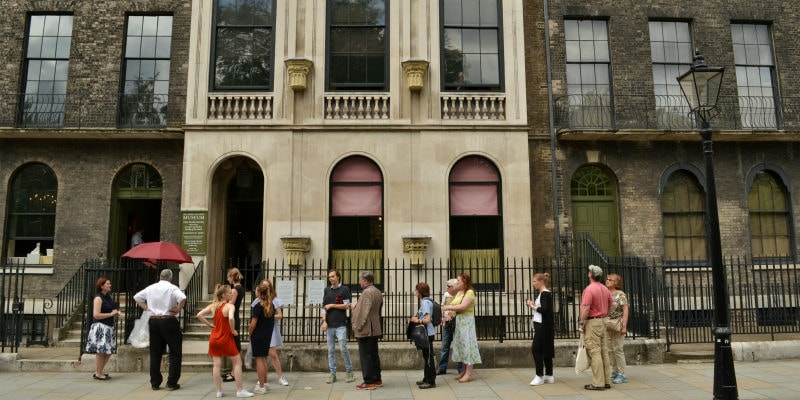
[564,20,613,128]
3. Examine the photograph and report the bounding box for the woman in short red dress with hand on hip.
[197,285,253,397]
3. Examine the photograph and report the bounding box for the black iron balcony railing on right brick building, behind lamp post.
[553,94,800,131]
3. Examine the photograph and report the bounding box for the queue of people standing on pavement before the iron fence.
[92,265,628,397]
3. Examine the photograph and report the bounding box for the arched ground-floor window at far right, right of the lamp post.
[747,170,794,259]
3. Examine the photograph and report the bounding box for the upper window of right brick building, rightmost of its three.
[731,24,777,128]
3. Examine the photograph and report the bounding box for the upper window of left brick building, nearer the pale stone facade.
[119,15,172,128]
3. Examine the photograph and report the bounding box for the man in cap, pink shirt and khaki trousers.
[578,265,614,390]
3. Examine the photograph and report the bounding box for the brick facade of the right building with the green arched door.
[526,0,800,263]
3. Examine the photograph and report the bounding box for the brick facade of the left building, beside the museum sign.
[0,0,191,296]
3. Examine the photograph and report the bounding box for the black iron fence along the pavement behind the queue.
[0,251,800,352]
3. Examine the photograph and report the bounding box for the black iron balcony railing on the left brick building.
[0,92,186,130]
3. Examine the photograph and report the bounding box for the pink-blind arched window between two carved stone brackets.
[328,156,383,287]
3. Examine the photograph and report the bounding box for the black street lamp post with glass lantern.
[678,50,739,400]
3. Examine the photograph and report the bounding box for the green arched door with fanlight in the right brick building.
[571,166,620,257]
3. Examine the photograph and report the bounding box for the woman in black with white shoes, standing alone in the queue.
[526,272,556,386]
